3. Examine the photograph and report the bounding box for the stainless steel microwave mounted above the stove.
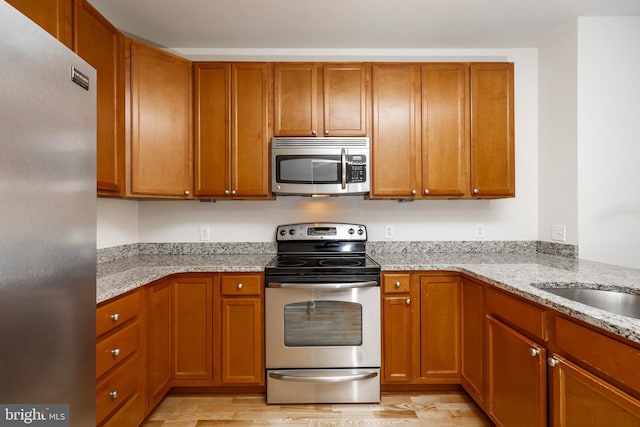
[271,137,371,196]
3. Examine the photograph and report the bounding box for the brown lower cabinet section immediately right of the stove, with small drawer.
[382,273,460,385]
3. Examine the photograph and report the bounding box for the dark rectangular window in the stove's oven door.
[284,301,362,347]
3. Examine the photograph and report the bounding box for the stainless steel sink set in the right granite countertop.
[533,283,640,319]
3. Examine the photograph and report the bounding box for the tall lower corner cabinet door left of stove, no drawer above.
[173,277,213,385]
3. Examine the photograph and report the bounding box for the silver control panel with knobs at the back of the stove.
[276,222,367,242]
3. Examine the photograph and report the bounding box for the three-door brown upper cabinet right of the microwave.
[371,63,515,199]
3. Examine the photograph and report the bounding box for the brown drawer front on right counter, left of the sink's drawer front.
[485,288,548,341]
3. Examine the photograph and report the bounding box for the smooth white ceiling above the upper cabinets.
[89,0,640,50]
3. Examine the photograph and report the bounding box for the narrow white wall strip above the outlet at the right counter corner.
[538,21,579,244]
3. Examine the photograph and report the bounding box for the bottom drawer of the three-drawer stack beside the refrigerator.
[96,354,139,424]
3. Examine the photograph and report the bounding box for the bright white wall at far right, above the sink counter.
[577,17,640,268]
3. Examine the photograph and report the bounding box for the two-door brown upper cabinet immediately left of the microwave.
[194,62,272,199]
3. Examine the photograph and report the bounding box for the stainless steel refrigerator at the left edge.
[0,1,96,427]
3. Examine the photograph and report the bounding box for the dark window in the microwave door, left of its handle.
[276,155,341,184]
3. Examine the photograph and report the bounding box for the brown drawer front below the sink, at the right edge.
[552,316,640,393]
